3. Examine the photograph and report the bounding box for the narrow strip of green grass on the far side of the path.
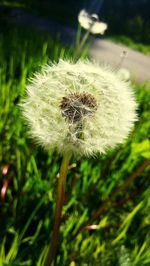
[109,36,150,55]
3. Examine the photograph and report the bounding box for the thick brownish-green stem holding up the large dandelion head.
[45,152,72,266]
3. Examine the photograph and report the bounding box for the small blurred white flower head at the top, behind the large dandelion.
[78,9,107,34]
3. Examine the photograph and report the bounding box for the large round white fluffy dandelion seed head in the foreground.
[22,60,137,155]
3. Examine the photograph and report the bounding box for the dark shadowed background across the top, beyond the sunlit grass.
[0,0,150,44]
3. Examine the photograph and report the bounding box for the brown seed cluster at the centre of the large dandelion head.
[60,92,97,123]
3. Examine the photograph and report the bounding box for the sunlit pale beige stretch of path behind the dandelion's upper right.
[90,39,150,82]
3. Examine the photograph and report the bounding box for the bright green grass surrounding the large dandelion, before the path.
[0,26,150,266]
